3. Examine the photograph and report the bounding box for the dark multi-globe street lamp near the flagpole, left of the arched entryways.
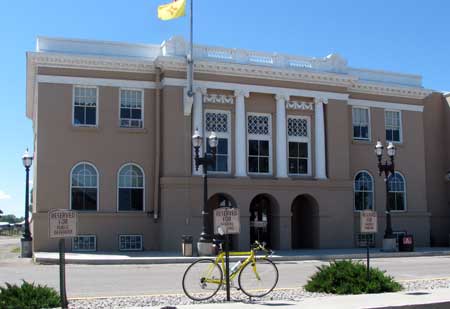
[192,129,219,256]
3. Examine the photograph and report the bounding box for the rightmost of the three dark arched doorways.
[291,194,319,249]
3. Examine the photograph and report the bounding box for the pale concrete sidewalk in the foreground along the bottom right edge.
[151,289,450,309]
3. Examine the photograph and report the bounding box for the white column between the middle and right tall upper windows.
[275,94,288,177]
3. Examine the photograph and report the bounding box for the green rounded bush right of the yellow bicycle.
[305,261,402,294]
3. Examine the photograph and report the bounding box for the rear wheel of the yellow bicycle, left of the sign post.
[183,259,223,300]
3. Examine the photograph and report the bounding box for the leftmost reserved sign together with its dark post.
[48,209,77,309]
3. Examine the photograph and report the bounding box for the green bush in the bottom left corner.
[0,281,61,309]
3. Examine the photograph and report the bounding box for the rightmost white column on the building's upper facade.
[314,97,328,179]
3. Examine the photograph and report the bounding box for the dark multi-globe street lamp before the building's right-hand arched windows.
[375,141,396,251]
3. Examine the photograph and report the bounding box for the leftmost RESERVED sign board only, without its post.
[48,209,77,238]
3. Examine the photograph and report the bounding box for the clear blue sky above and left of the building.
[0,0,450,215]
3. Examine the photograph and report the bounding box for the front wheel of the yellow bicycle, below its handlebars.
[238,258,278,297]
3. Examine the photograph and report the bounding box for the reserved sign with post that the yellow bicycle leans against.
[214,207,241,301]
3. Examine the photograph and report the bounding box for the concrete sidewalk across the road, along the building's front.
[33,247,450,265]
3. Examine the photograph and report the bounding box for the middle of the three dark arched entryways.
[250,194,279,249]
